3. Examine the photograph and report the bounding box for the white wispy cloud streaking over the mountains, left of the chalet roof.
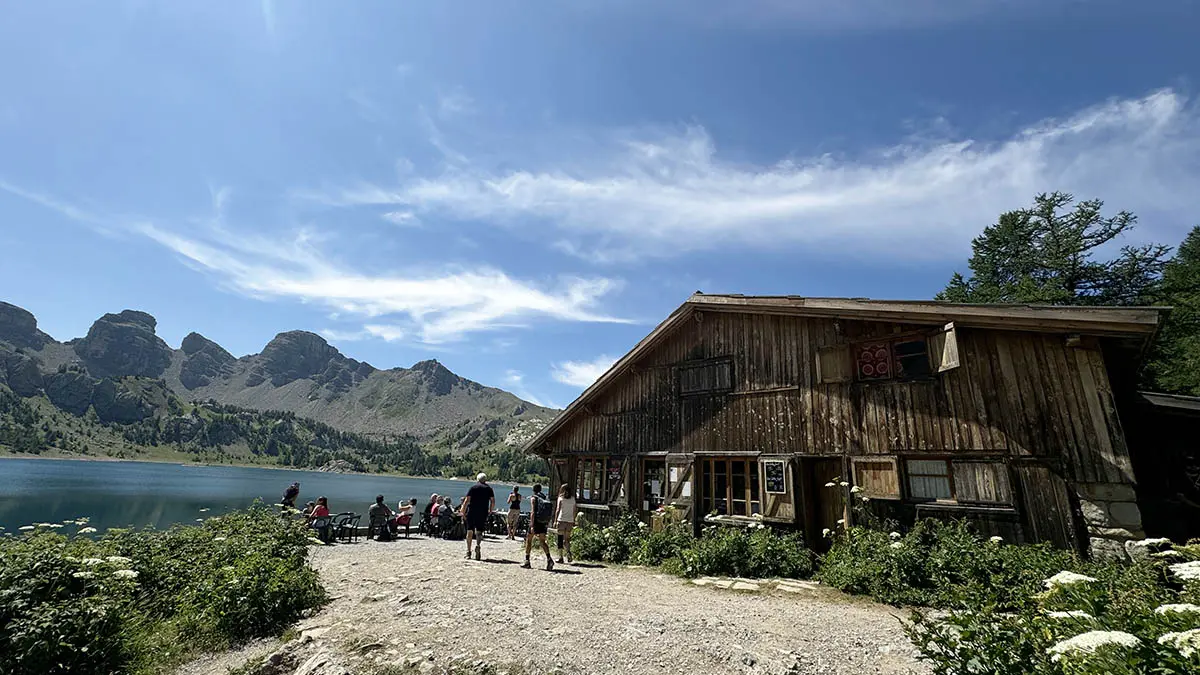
[0,181,629,345]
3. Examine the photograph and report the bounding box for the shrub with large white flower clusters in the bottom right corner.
[906,540,1200,675]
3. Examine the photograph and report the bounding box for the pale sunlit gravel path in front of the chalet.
[188,538,928,675]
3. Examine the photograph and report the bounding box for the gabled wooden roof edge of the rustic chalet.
[526,292,1170,452]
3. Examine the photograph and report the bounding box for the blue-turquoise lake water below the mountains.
[0,459,529,532]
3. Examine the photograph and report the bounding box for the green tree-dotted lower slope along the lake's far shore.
[0,378,546,482]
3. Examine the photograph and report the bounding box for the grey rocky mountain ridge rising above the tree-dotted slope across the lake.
[0,303,557,475]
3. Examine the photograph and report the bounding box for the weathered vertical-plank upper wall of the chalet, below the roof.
[547,312,1133,483]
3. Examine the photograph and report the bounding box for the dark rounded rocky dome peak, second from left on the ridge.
[74,310,170,377]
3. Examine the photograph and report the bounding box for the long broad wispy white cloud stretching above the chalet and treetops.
[307,90,1200,262]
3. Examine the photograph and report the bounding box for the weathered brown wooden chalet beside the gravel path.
[527,293,1166,557]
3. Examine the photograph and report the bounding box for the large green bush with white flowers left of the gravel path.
[0,507,325,675]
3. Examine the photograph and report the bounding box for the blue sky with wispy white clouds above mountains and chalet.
[0,0,1200,406]
